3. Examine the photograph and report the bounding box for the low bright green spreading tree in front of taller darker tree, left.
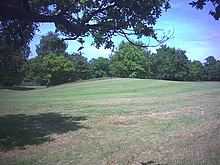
[25,54,75,86]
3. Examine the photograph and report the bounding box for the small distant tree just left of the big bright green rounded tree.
[89,57,111,78]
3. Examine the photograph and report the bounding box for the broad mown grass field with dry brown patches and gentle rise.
[0,79,220,165]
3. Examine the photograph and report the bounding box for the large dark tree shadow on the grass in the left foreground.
[0,113,86,151]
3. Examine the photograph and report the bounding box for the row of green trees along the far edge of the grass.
[1,33,220,86]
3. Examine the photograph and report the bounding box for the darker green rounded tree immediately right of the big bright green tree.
[152,45,189,80]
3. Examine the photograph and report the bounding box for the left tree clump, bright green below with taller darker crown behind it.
[23,32,76,85]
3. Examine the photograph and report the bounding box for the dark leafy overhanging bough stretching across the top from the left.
[0,0,170,48]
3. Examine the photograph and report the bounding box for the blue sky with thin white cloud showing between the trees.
[30,0,220,62]
